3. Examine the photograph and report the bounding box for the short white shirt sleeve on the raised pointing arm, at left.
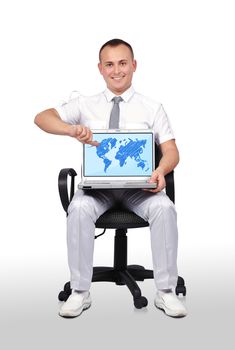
[55,97,81,124]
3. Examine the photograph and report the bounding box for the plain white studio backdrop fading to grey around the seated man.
[0,0,235,349]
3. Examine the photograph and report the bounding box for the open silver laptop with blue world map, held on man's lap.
[78,129,157,190]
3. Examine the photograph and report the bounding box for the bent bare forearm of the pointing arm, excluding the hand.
[34,108,71,135]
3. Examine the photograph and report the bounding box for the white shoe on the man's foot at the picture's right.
[154,291,187,317]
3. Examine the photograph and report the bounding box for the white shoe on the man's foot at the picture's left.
[59,291,91,317]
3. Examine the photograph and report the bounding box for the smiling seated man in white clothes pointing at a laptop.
[35,39,187,317]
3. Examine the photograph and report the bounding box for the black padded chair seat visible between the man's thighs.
[95,209,149,229]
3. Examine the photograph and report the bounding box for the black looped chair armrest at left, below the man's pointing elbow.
[58,168,77,213]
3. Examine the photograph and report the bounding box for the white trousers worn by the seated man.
[67,190,178,291]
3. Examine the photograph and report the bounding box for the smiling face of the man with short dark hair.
[98,45,136,95]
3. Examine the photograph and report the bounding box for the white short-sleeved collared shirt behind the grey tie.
[55,86,174,145]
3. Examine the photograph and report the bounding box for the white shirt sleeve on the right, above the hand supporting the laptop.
[153,105,175,145]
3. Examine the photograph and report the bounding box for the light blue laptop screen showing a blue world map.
[83,132,154,177]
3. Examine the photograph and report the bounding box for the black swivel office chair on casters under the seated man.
[58,147,186,309]
